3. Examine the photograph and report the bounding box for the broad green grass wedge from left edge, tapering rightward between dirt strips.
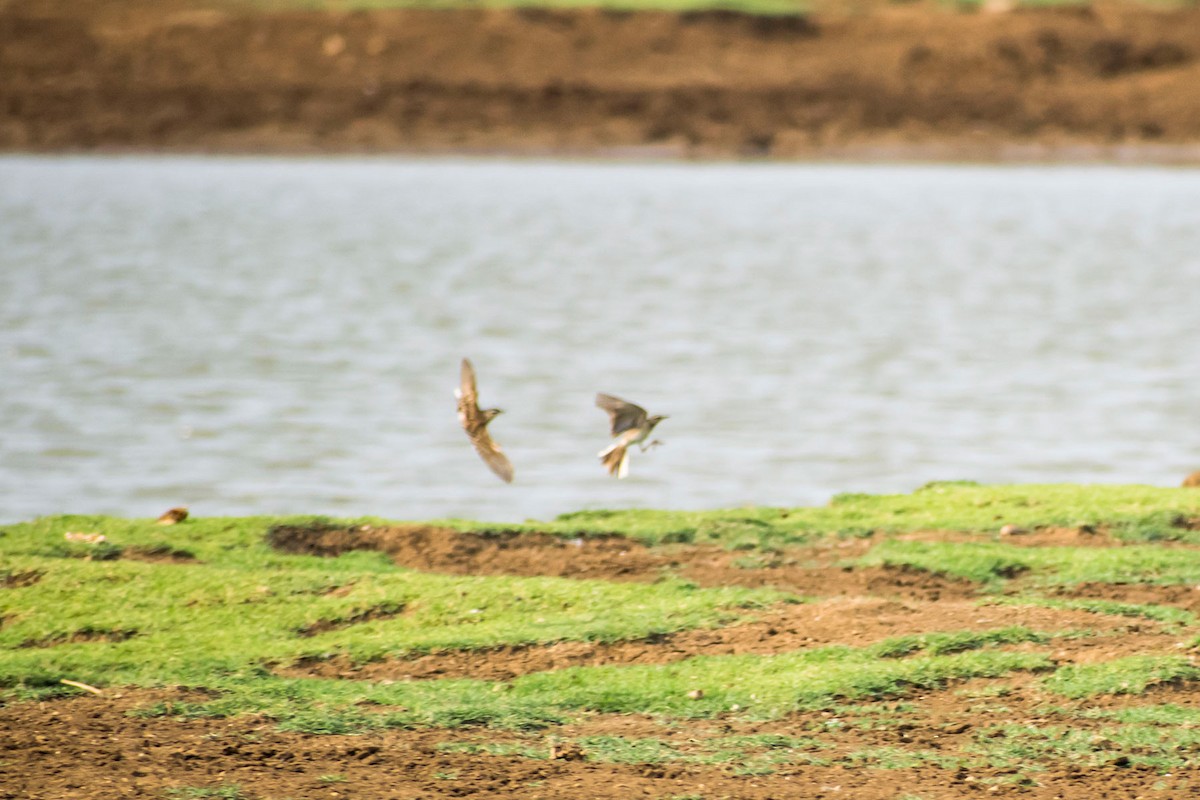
[0,553,787,686]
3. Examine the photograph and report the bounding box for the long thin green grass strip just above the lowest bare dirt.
[103,648,1050,733]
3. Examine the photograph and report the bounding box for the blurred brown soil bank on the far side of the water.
[7,0,1200,161]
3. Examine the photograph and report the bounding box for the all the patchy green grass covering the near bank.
[0,483,1200,770]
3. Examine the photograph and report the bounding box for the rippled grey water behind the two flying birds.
[0,157,1200,521]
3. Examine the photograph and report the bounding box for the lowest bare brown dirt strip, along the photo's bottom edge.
[0,684,1200,800]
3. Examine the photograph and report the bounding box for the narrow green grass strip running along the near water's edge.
[9,482,1200,569]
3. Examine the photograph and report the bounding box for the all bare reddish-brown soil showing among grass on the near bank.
[7,523,1200,800]
